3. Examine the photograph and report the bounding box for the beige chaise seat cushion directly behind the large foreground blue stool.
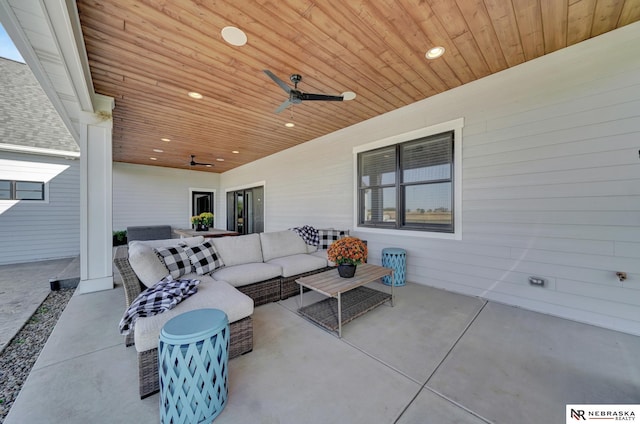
[134,274,253,352]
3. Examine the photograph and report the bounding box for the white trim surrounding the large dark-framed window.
[353,118,464,240]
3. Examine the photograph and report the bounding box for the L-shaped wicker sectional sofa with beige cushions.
[114,230,344,398]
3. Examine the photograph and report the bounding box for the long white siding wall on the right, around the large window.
[219,23,640,334]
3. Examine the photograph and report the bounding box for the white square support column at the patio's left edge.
[78,96,113,293]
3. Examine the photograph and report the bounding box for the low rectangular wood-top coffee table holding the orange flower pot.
[296,264,394,337]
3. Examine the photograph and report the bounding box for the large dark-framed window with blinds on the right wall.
[358,131,454,233]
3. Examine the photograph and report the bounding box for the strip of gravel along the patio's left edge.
[0,289,75,423]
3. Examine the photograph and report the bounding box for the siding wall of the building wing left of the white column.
[0,152,80,265]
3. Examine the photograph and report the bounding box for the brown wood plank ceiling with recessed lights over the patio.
[77,0,640,172]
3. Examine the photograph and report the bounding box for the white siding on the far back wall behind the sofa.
[113,162,219,231]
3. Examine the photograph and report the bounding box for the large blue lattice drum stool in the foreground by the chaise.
[158,309,229,424]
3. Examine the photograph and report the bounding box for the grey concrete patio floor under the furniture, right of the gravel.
[5,262,640,424]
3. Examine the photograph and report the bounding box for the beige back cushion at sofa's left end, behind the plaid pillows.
[129,236,204,287]
